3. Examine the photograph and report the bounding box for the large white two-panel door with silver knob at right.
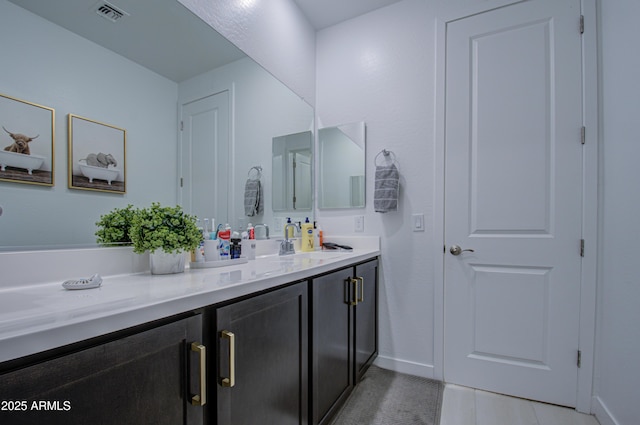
[444,0,582,406]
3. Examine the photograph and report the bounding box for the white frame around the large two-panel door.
[433,0,600,413]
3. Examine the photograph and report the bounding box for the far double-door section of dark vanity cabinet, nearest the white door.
[311,260,378,425]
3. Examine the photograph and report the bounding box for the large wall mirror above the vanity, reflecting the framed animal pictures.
[0,0,314,251]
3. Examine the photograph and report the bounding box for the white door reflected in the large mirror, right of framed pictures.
[179,91,231,224]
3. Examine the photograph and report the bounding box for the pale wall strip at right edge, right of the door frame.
[595,0,640,425]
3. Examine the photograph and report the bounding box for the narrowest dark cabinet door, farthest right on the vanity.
[354,260,378,382]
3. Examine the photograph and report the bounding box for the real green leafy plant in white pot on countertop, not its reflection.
[129,202,202,274]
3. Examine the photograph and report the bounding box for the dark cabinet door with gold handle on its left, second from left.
[216,281,309,425]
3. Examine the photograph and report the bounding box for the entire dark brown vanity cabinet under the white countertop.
[0,259,378,425]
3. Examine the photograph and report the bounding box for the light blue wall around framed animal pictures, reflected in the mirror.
[0,0,177,249]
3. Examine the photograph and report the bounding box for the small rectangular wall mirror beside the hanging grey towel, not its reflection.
[318,122,366,209]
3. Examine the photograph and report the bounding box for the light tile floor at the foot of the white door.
[440,384,599,425]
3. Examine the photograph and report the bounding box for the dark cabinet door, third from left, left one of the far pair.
[312,267,355,424]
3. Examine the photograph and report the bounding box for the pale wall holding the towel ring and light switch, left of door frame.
[315,0,442,378]
